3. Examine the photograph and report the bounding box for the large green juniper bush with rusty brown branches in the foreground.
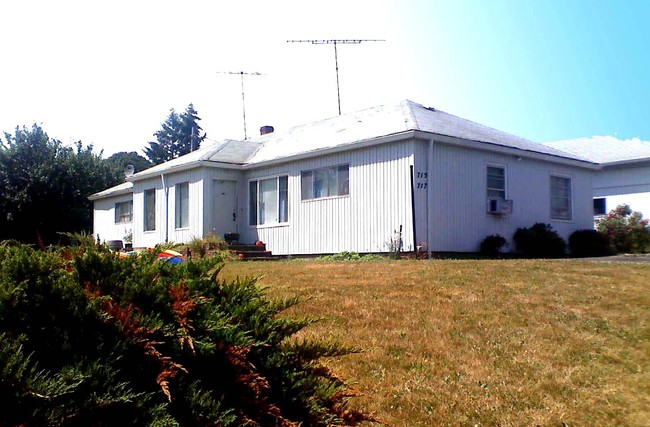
[0,239,364,426]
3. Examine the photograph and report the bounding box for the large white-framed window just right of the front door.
[248,176,289,225]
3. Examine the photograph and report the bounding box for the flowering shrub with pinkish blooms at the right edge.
[596,205,650,253]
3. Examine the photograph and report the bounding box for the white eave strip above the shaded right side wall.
[415,131,602,170]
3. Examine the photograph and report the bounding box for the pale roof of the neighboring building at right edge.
[544,136,650,165]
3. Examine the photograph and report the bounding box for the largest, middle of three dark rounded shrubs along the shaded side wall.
[513,222,566,258]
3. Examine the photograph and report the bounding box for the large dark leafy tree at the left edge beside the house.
[0,124,123,244]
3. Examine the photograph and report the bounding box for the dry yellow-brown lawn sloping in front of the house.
[223,260,650,427]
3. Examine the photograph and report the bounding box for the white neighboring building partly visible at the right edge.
[544,136,650,218]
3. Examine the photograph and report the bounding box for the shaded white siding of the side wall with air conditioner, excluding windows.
[429,144,593,252]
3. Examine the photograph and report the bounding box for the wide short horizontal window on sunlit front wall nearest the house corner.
[300,165,350,200]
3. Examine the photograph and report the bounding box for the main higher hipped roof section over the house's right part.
[246,100,586,164]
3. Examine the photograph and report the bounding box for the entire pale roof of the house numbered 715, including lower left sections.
[91,100,590,198]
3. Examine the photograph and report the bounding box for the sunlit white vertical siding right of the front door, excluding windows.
[239,141,414,254]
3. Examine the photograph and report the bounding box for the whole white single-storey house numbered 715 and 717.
[91,101,599,254]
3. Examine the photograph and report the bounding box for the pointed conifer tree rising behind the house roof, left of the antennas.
[144,104,205,165]
